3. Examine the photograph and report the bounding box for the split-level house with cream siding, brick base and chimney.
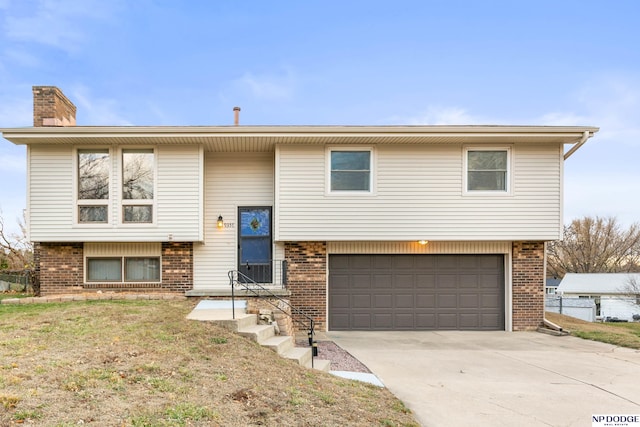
[2,86,598,331]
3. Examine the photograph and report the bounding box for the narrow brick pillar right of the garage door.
[512,242,545,331]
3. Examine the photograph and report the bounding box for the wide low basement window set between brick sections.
[87,257,160,282]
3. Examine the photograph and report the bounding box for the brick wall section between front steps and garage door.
[284,242,327,331]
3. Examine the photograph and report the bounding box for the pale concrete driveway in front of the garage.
[327,331,640,427]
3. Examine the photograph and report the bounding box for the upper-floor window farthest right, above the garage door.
[465,147,511,193]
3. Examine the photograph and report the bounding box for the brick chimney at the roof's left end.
[33,86,76,127]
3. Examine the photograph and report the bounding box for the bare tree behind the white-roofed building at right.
[547,216,640,277]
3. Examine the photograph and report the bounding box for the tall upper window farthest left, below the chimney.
[77,149,111,224]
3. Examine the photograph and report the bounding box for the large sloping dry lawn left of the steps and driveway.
[0,301,418,427]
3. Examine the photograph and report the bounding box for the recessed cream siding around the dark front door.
[194,152,282,289]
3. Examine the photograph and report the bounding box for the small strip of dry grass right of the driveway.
[545,312,640,349]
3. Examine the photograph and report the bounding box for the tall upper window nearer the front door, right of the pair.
[122,149,155,224]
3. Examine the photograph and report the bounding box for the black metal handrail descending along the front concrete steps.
[228,270,318,368]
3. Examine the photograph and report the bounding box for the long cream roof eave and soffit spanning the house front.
[2,126,599,152]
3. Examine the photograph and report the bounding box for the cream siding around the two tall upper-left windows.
[28,145,203,242]
